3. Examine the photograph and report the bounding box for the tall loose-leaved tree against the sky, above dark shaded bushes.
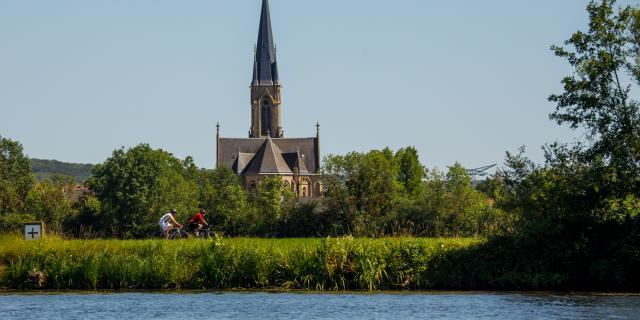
[547,0,640,219]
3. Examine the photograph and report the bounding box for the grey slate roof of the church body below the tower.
[218,138,319,175]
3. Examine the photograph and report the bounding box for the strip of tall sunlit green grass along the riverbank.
[0,236,482,290]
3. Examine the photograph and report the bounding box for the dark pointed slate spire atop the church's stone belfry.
[252,0,279,85]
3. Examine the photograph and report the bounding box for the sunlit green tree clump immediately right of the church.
[325,147,502,236]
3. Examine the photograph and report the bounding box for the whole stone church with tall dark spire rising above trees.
[216,0,322,198]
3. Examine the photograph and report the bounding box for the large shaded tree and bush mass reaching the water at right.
[468,0,640,290]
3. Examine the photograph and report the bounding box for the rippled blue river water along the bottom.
[0,292,640,320]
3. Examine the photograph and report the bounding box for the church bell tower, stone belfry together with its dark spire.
[249,0,284,138]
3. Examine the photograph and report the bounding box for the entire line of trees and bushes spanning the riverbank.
[0,0,640,290]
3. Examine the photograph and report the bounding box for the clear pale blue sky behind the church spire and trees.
[0,0,632,168]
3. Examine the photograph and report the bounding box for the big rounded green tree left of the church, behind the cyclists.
[88,144,199,237]
